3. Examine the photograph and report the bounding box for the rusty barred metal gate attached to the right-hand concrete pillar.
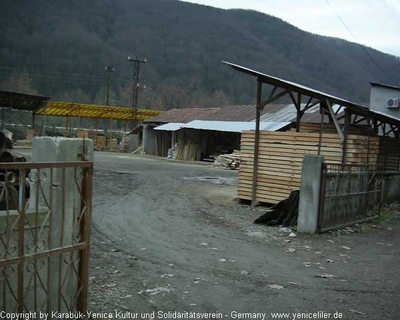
[318,163,382,232]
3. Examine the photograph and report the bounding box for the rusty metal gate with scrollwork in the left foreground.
[0,161,93,313]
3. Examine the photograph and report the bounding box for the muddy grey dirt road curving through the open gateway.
[89,153,400,319]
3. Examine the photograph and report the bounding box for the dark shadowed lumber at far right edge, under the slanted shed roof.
[378,137,400,171]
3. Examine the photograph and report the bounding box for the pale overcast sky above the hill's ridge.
[185,0,400,57]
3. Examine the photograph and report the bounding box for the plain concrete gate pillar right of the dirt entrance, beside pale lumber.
[297,154,324,234]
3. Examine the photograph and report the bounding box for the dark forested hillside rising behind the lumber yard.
[0,0,400,109]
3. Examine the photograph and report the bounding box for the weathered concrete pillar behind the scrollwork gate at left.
[27,137,93,312]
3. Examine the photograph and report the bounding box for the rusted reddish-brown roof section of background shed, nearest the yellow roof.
[144,108,219,123]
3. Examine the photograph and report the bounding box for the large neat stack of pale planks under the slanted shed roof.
[238,131,379,204]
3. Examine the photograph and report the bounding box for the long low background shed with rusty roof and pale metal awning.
[143,104,330,161]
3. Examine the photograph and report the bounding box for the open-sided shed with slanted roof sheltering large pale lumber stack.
[224,62,400,204]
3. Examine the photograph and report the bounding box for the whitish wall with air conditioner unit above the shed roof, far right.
[369,85,400,119]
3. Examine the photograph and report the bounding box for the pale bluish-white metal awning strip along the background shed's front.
[182,120,291,133]
